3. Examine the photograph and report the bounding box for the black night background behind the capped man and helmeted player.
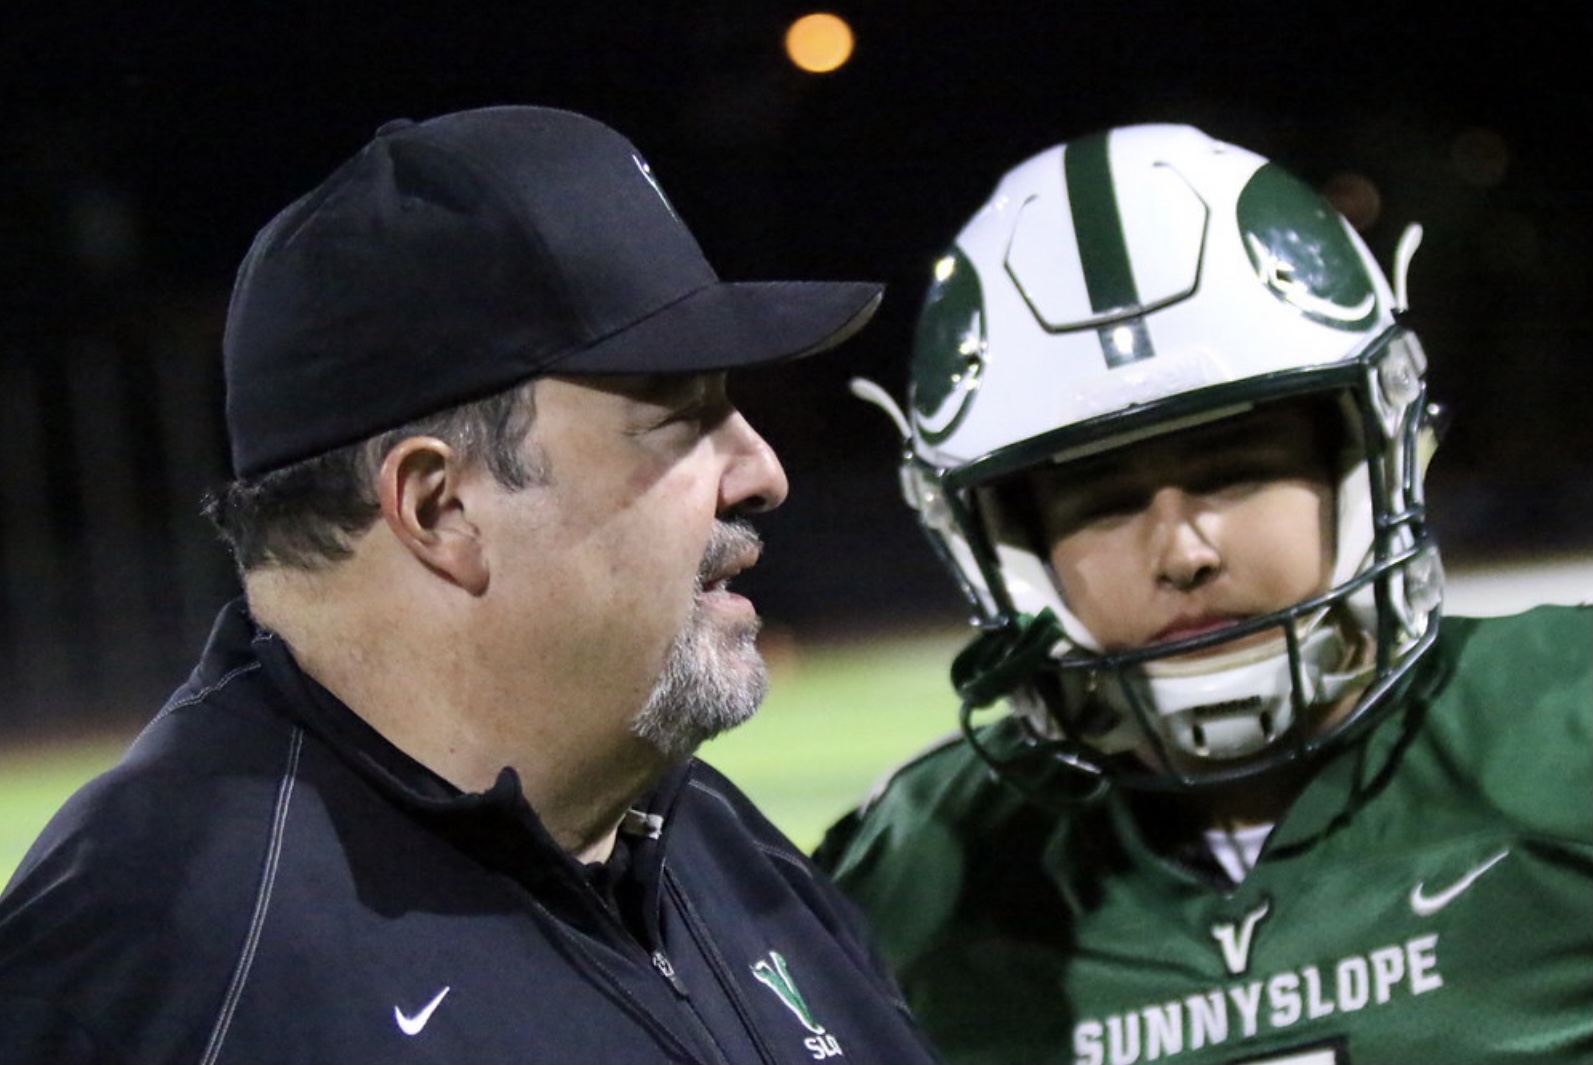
[0,0,1593,731]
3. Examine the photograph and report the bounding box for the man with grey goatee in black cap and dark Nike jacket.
[0,108,929,1063]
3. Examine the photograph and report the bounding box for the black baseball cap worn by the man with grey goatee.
[223,107,881,478]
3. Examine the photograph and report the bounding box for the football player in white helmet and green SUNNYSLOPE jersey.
[820,126,1593,1065]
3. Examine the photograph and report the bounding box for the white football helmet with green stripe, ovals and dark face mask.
[873,126,1442,785]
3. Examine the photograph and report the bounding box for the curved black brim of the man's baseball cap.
[540,282,884,374]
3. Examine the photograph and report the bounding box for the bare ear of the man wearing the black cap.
[378,436,487,595]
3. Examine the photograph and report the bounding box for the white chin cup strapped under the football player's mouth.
[1102,616,1352,761]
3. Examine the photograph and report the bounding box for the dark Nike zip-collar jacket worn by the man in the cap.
[0,603,930,1065]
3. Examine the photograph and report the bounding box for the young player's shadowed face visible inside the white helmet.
[1032,404,1333,653]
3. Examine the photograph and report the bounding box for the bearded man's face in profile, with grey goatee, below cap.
[477,374,787,759]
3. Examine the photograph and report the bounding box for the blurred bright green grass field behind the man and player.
[0,630,965,884]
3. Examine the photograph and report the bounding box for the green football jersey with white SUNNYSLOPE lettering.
[820,607,1593,1065]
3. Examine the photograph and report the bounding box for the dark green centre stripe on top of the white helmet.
[1063,134,1155,366]
